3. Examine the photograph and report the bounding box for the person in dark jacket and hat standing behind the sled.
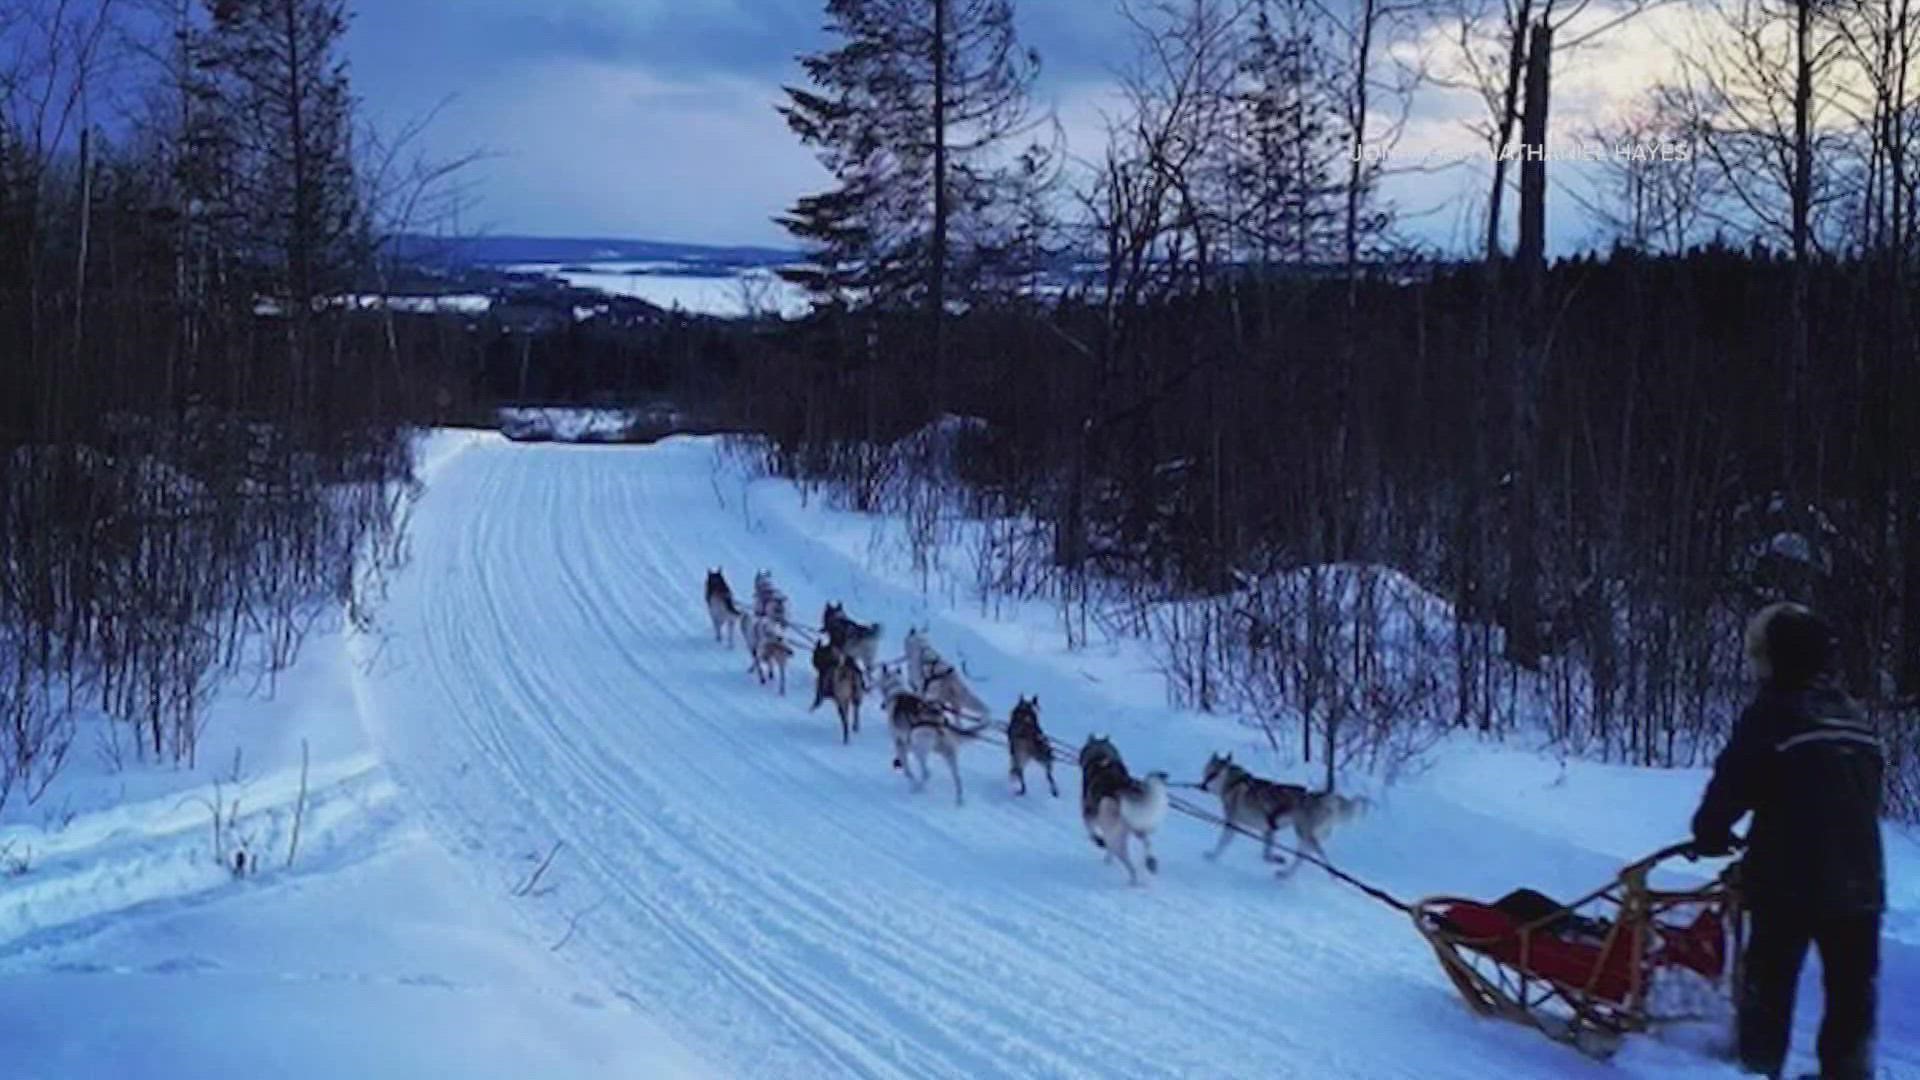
[1693,603,1885,1080]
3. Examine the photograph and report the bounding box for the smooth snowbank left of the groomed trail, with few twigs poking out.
[0,426,710,1080]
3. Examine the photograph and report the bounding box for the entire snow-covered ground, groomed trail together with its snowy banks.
[11,434,1920,1080]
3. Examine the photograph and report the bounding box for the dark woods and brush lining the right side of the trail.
[721,0,1920,817]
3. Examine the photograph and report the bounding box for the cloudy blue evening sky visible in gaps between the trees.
[349,0,1697,250]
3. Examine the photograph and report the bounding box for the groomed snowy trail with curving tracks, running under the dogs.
[363,440,1904,1078]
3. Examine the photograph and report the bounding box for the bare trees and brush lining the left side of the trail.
[0,0,445,803]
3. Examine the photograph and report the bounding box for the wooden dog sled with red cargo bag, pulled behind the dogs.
[1413,844,1741,1057]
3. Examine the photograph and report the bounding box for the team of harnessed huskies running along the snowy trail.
[707,569,1365,884]
